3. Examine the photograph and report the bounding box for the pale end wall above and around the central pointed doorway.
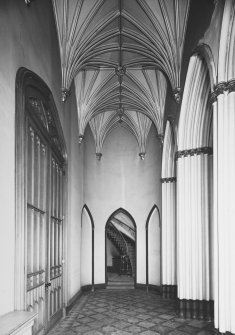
[84,123,161,284]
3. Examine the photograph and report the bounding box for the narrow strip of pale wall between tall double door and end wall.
[65,82,84,302]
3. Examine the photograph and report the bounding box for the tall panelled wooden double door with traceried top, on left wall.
[25,92,64,334]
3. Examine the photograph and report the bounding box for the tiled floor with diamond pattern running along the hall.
[48,289,218,335]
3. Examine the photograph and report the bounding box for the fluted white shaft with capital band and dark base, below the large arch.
[176,147,213,320]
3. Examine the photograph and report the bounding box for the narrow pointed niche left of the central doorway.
[81,205,94,291]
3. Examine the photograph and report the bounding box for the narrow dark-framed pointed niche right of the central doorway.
[146,205,161,290]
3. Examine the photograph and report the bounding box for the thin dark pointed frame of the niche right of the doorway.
[145,204,161,291]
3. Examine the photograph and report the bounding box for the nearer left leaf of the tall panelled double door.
[26,123,48,334]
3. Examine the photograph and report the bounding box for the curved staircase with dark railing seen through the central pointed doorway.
[106,223,136,284]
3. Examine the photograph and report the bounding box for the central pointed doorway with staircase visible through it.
[105,208,136,289]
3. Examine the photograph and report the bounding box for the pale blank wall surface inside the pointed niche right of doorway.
[148,208,161,286]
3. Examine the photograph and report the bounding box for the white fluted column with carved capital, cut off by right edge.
[211,79,235,333]
